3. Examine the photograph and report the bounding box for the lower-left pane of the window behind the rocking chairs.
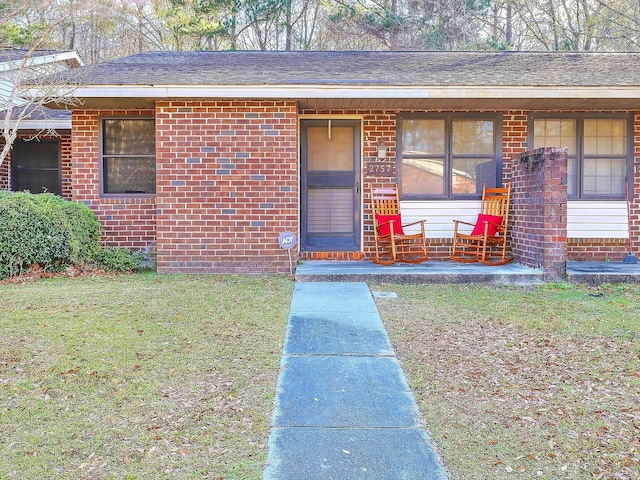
[402,158,444,195]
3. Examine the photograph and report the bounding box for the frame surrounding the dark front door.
[298,114,364,252]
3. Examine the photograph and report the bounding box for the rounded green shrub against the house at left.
[0,192,100,279]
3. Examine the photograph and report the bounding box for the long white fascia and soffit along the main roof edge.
[41,84,640,109]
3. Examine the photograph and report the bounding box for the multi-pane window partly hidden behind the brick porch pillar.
[532,115,631,199]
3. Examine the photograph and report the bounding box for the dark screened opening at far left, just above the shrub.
[11,139,62,195]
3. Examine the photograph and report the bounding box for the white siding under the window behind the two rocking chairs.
[400,200,480,238]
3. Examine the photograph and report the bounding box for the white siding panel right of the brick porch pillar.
[567,201,629,238]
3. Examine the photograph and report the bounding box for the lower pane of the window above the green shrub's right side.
[103,157,156,193]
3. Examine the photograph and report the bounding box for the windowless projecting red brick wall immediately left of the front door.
[156,101,298,273]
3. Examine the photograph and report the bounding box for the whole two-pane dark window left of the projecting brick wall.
[101,118,156,195]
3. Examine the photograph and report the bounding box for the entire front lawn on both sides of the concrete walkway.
[0,273,640,480]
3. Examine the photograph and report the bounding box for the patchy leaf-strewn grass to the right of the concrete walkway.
[373,284,640,480]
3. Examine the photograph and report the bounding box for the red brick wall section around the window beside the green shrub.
[71,110,156,250]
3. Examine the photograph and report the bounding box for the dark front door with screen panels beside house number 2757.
[300,119,361,251]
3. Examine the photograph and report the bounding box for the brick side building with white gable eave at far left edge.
[0,48,82,198]
